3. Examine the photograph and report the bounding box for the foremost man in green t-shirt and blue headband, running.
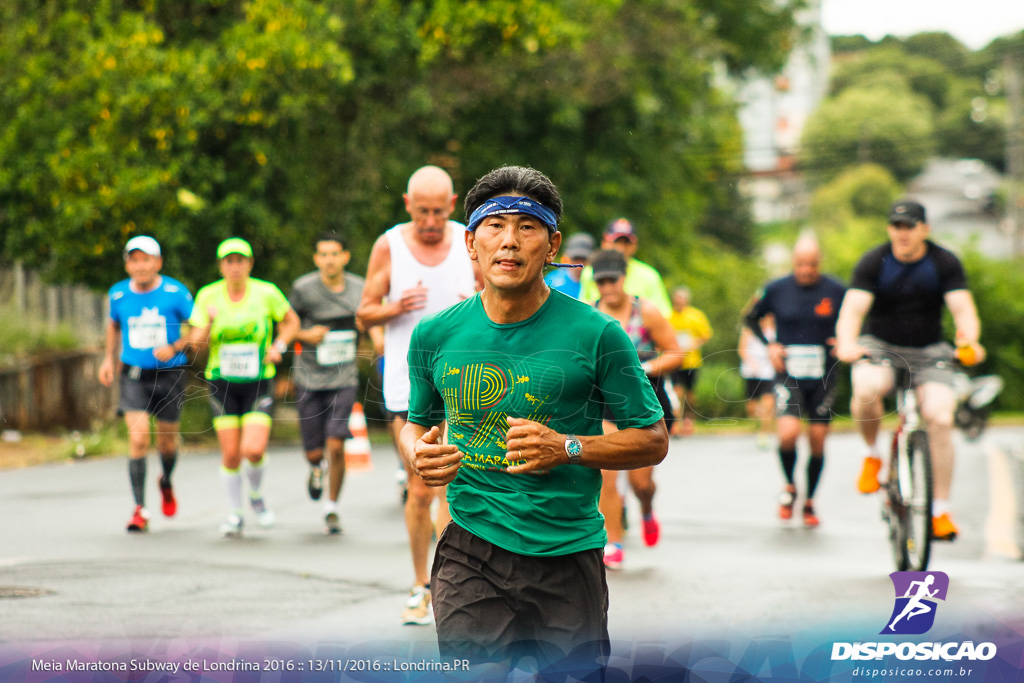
[399,167,668,669]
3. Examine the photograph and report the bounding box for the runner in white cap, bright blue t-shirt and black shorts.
[99,236,193,531]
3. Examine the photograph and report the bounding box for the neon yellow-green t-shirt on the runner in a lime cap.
[188,278,291,382]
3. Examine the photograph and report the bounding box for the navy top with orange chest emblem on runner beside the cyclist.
[745,275,846,346]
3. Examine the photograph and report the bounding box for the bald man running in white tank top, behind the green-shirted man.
[356,166,480,625]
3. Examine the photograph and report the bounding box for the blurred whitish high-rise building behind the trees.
[736,0,831,222]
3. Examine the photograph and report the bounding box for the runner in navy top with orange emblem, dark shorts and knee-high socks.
[743,237,846,527]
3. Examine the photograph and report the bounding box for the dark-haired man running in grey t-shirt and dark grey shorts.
[288,232,364,533]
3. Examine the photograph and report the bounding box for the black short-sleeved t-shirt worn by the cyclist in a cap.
[850,240,967,348]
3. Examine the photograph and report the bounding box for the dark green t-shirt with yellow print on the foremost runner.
[409,291,663,555]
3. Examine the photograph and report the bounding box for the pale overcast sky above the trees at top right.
[821,0,1024,50]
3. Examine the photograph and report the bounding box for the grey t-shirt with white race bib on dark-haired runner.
[288,270,366,390]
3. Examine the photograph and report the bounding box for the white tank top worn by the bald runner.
[384,220,476,413]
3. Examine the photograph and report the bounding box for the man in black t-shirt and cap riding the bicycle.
[836,200,984,541]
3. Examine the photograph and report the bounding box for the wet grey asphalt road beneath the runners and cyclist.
[0,423,1024,659]
